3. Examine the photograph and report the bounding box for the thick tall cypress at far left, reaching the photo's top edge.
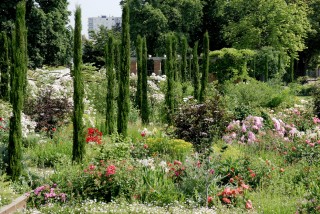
[8,1,27,181]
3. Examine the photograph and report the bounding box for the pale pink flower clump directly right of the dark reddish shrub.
[223,116,263,144]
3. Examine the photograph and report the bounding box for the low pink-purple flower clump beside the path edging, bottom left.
[27,184,67,207]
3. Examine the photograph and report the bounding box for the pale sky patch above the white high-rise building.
[68,0,121,38]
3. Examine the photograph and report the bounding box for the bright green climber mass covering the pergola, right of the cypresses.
[209,48,255,83]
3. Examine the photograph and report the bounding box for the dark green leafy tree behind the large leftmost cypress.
[0,0,72,67]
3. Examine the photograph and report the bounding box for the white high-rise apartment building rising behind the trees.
[88,16,122,35]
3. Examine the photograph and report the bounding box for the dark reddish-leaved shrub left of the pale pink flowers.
[174,94,227,152]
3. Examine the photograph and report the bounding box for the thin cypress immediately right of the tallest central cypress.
[136,35,143,110]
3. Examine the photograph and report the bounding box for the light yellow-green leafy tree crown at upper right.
[223,0,310,56]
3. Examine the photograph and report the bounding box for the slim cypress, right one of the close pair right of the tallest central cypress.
[141,37,149,124]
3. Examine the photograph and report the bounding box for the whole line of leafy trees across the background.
[0,0,320,76]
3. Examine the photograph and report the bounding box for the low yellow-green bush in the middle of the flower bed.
[146,138,193,159]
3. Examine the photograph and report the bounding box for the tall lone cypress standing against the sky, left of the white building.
[72,6,85,163]
